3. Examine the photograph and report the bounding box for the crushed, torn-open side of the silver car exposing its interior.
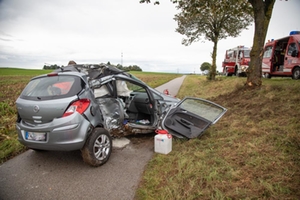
[90,75,158,135]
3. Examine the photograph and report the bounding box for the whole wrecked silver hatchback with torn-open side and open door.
[16,64,226,166]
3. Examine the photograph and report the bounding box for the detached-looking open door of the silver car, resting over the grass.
[162,97,227,138]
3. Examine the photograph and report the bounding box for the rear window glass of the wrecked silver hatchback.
[20,75,84,100]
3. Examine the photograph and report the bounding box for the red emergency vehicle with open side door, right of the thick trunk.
[262,31,300,79]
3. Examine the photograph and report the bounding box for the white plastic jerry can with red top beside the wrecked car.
[154,129,172,154]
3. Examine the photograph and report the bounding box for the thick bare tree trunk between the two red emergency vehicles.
[246,0,275,87]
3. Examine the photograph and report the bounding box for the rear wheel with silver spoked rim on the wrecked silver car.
[81,128,112,167]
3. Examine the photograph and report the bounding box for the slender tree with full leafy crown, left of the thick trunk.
[173,0,253,80]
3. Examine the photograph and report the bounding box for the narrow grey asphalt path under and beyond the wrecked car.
[0,76,185,200]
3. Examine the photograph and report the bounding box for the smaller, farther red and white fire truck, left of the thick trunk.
[222,46,251,76]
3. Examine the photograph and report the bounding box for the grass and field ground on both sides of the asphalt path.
[0,68,300,199]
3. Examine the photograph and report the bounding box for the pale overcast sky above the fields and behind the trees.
[0,0,300,73]
